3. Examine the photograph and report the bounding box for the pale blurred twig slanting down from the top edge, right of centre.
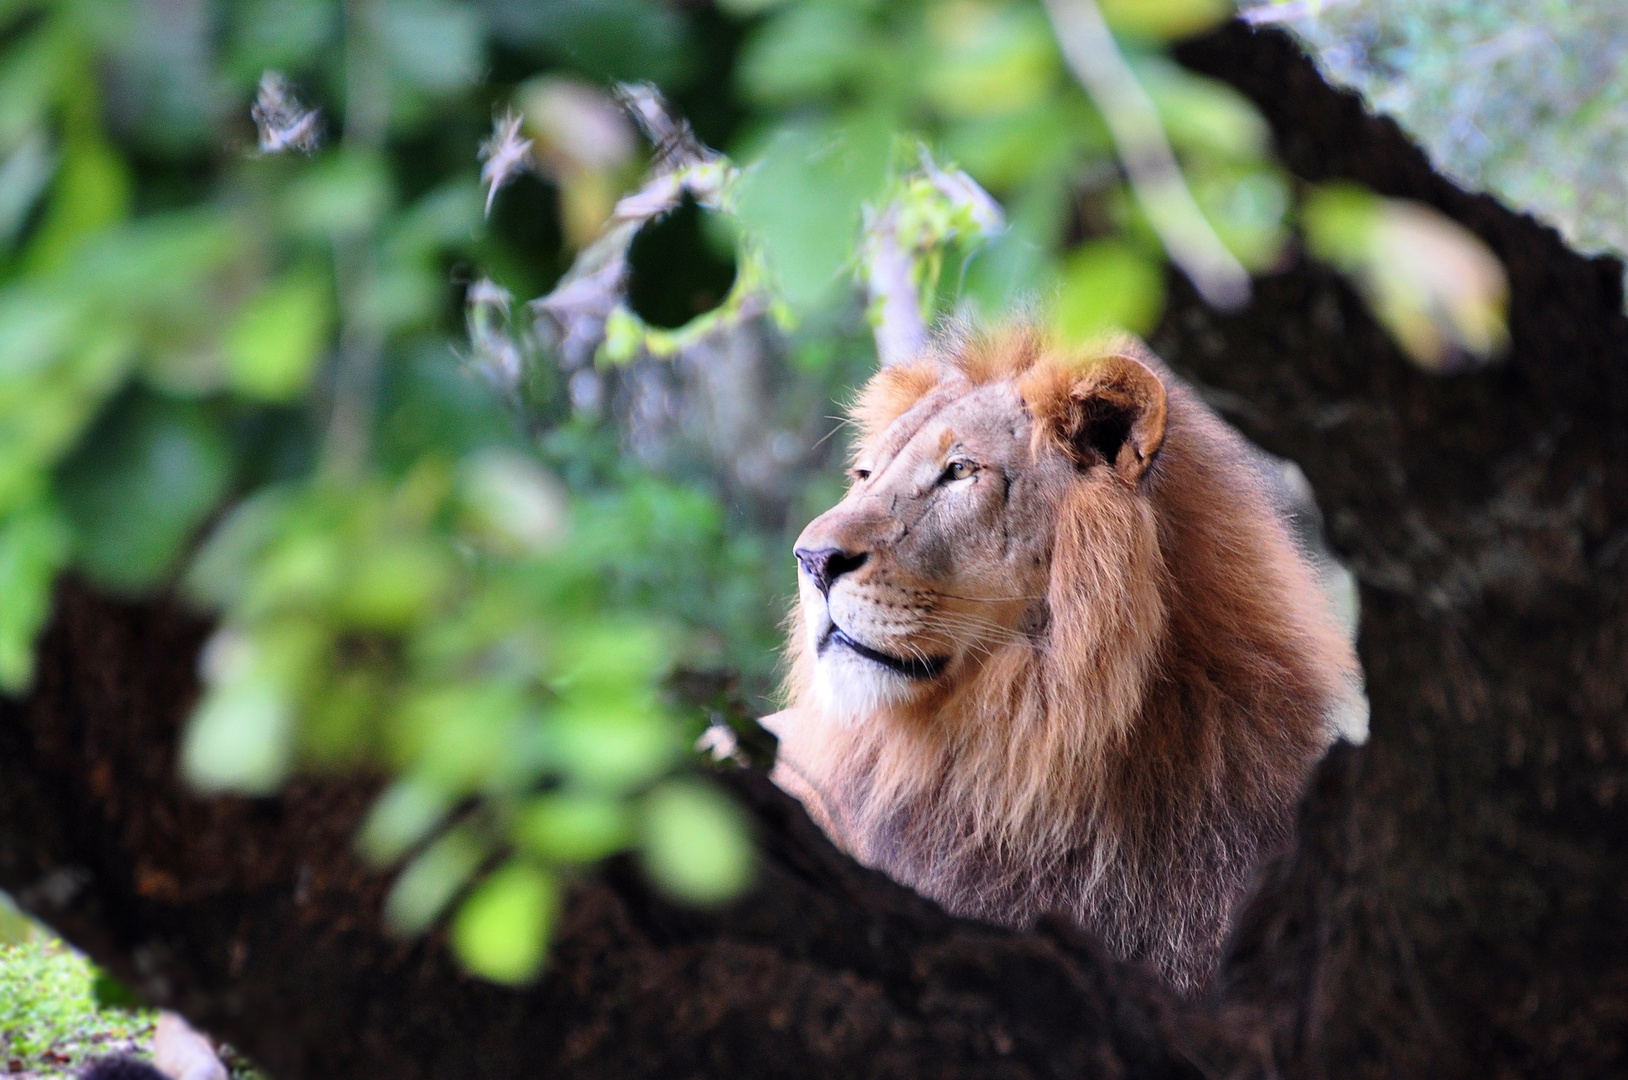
[1045,0,1249,310]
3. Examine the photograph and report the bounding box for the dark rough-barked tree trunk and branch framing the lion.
[0,26,1628,1080]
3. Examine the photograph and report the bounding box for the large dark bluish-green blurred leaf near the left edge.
[59,396,233,591]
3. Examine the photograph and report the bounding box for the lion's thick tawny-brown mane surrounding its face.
[777,329,1354,992]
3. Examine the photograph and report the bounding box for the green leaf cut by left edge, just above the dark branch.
[0,503,70,694]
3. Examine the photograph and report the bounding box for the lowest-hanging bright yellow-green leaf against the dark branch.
[453,860,560,984]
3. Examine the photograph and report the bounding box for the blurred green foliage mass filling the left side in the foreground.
[0,0,773,981]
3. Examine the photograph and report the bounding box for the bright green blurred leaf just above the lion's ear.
[1057,239,1164,344]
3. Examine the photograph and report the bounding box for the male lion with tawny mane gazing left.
[765,329,1356,994]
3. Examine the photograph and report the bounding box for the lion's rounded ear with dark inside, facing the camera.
[1065,357,1166,484]
